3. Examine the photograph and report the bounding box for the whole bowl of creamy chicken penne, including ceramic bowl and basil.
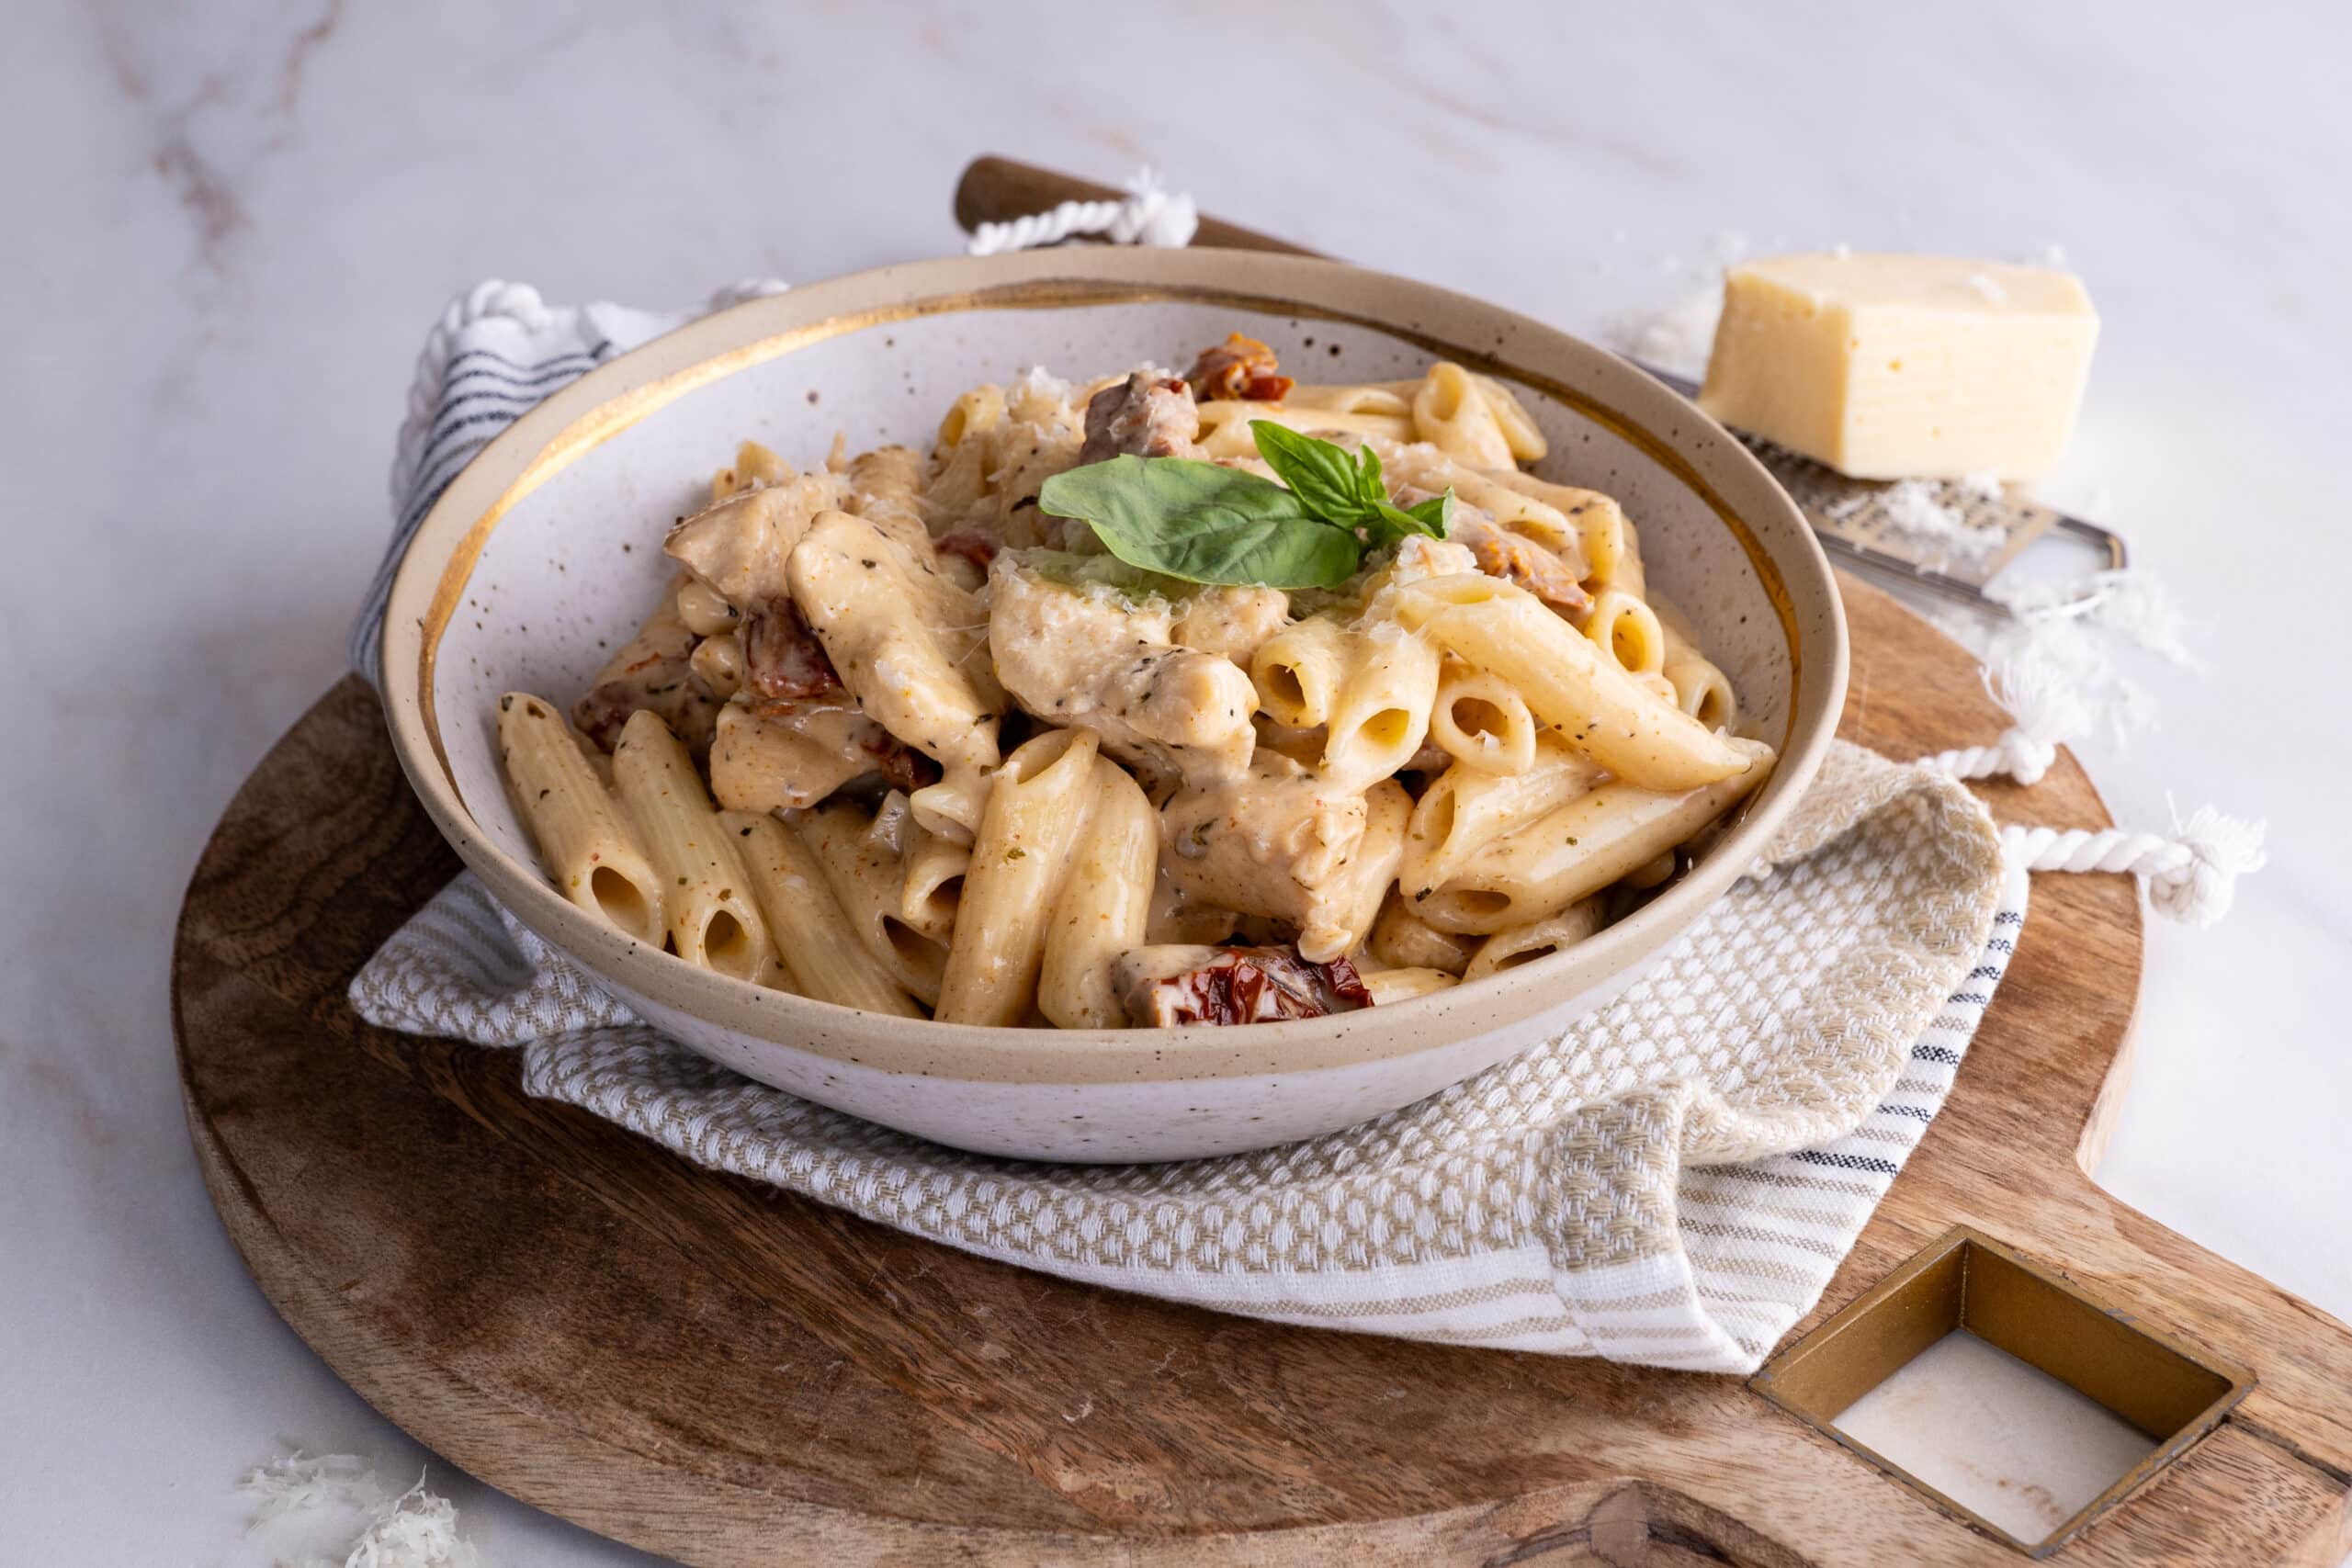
[383,254,1844,1159]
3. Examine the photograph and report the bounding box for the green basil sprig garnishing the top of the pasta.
[1037,419,1453,588]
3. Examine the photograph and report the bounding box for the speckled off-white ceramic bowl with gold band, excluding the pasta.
[383,247,1847,1161]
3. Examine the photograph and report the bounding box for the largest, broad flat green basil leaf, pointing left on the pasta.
[1037,456,1364,588]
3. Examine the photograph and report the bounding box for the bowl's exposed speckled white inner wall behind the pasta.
[433,301,1792,884]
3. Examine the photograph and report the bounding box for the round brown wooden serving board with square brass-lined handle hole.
[172,581,2352,1568]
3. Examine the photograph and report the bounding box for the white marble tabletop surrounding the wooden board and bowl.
[0,0,2352,1565]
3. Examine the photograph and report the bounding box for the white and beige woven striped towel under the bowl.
[350,285,2025,1373]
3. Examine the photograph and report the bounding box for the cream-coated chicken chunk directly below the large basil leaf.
[988,555,1259,783]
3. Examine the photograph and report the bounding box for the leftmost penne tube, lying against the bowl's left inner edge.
[499,691,668,947]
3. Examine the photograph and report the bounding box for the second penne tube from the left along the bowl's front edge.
[612,710,776,983]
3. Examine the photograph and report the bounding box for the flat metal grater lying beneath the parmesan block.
[1634,360,2126,616]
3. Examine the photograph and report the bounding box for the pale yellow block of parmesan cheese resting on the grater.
[1698,254,2098,479]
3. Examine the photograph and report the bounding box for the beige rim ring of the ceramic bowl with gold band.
[381,247,1849,1084]
